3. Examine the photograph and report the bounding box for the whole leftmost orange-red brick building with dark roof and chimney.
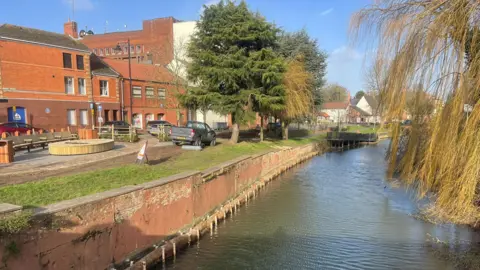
[0,22,120,129]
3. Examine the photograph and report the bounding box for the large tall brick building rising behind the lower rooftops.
[82,17,177,65]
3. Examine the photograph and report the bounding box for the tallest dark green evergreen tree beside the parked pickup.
[187,1,278,143]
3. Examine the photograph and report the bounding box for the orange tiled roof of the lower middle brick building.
[102,58,175,83]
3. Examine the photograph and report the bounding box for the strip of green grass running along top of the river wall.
[0,134,324,207]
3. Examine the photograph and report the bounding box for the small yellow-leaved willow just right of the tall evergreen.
[281,56,314,140]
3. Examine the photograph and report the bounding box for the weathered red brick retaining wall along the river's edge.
[0,144,319,270]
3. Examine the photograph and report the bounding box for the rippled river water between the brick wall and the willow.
[162,142,478,270]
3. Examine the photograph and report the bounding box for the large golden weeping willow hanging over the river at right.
[352,0,480,224]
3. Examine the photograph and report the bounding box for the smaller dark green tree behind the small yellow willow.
[278,29,327,107]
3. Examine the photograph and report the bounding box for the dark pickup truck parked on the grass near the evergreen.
[170,121,217,146]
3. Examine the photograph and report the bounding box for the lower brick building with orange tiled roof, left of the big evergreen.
[103,58,186,129]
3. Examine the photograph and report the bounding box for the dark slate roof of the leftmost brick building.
[0,24,89,52]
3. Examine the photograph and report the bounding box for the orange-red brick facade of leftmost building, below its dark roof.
[0,25,120,129]
